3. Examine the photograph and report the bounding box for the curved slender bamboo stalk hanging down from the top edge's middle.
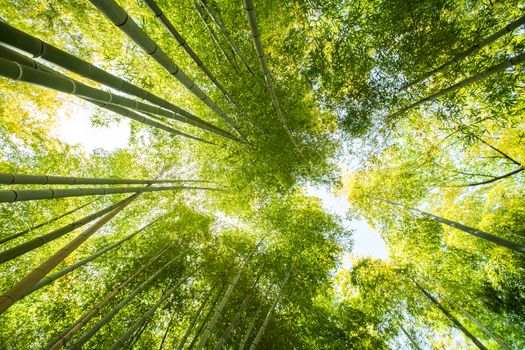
[243,0,302,155]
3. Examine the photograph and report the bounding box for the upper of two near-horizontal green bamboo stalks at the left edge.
[0,173,208,186]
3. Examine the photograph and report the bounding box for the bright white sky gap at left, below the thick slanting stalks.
[52,103,131,153]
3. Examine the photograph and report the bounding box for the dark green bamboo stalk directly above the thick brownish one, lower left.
[0,199,133,264]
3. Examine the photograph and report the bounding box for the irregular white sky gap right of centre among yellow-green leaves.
[307,185,388,262]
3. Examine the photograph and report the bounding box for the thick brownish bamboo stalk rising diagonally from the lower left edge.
[0,193,135,315]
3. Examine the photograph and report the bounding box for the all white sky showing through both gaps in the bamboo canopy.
[54,105,388,262]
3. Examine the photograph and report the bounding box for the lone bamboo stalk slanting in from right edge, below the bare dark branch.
[381,200,525,253]
